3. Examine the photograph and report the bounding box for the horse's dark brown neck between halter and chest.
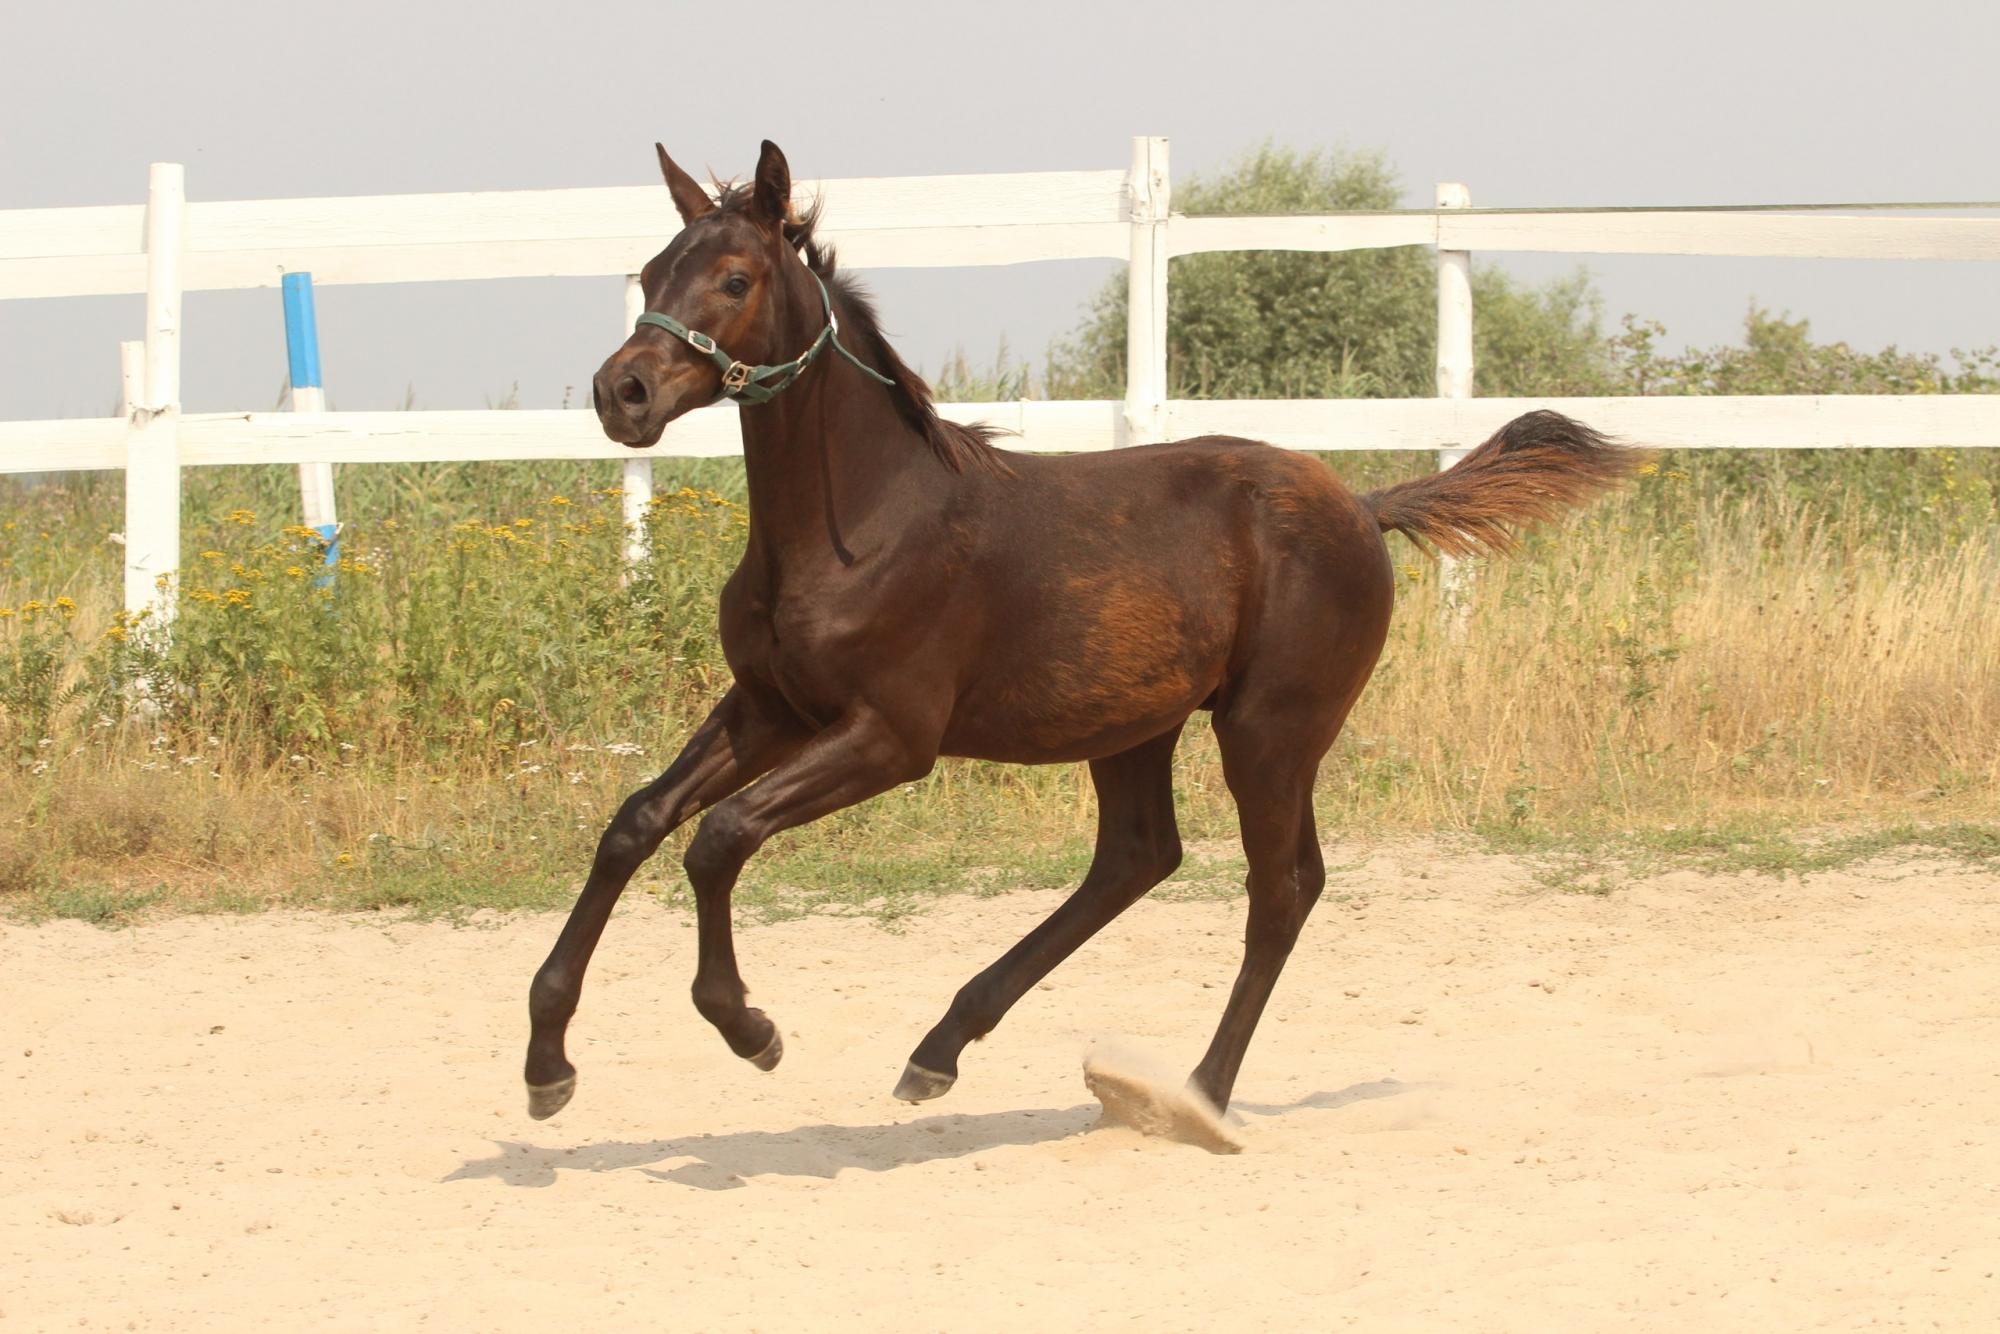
[742,288,952,564]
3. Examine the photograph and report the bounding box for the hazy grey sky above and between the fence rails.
[0,0,2000,420]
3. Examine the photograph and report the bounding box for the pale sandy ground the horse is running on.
[0,848,2000,1332]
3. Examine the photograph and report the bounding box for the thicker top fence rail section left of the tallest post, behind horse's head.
[0,172,1130,298]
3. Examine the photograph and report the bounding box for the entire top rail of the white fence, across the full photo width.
[0,183,2000,300]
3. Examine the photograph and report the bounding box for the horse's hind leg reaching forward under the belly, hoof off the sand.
[896,726,1180,1102]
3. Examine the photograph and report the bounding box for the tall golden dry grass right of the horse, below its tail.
[1344,486,2000,826]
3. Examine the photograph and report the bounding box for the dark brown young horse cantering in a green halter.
[526,142,1632,1118]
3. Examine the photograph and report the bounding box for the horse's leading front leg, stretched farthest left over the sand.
[524,686,810,1120]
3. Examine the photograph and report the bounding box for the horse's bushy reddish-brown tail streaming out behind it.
[1362,410,1646,556]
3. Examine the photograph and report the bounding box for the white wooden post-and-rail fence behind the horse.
[0,138,2000,610]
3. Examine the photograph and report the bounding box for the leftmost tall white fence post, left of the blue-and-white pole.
[126,162,188,620]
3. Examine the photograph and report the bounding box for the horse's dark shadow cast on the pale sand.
[444,1080,1418,1190]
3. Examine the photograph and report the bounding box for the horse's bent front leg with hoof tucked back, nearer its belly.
[682,712,936,1070]
